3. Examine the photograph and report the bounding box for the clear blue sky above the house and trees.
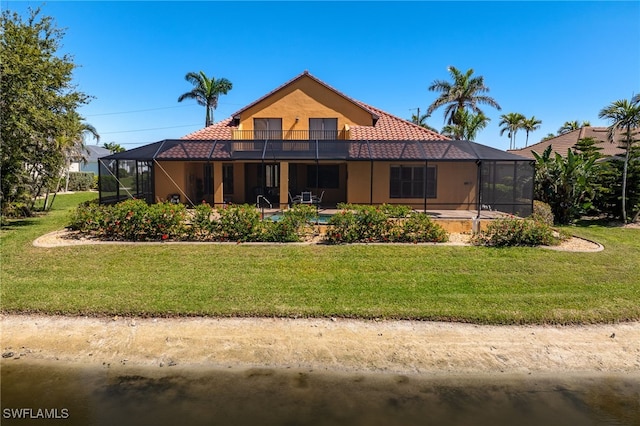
[5,0,640,149]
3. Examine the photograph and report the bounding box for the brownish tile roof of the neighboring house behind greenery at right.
[509,126,624,160]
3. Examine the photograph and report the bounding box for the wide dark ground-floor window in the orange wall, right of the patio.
[389,166,437,198]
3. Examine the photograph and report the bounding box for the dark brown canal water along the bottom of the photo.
[0,360,640,426]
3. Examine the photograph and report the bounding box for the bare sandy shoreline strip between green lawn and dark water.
[0,315,640,375]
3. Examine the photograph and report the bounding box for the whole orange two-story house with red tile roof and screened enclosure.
[100,71,534,216]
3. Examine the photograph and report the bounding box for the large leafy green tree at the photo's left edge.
[0,9,90,210]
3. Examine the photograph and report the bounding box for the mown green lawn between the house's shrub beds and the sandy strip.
[0,193,640,324]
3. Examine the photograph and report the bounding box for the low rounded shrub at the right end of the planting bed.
[472,218,559,247]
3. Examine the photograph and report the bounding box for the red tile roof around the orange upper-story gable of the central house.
[183,71,449,141]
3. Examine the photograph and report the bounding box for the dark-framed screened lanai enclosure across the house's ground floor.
[99,139,534,217]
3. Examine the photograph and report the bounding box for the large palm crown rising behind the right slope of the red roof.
[427,66,501,124]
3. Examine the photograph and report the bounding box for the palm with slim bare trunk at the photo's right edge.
[598,95,640,223]
